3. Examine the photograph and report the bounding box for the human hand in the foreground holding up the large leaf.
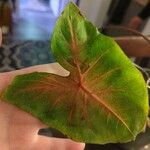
[0,63,85,150]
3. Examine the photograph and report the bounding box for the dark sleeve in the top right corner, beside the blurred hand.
[138,1,150,20]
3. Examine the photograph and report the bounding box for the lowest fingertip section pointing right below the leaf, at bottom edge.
[33,136,85,150]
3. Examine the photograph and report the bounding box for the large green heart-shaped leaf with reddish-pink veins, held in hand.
[3,3,148,144]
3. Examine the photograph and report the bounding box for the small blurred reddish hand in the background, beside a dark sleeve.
[129,16,143,30]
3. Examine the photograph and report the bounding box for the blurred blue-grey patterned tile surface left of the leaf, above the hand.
[0,40,55,72]
